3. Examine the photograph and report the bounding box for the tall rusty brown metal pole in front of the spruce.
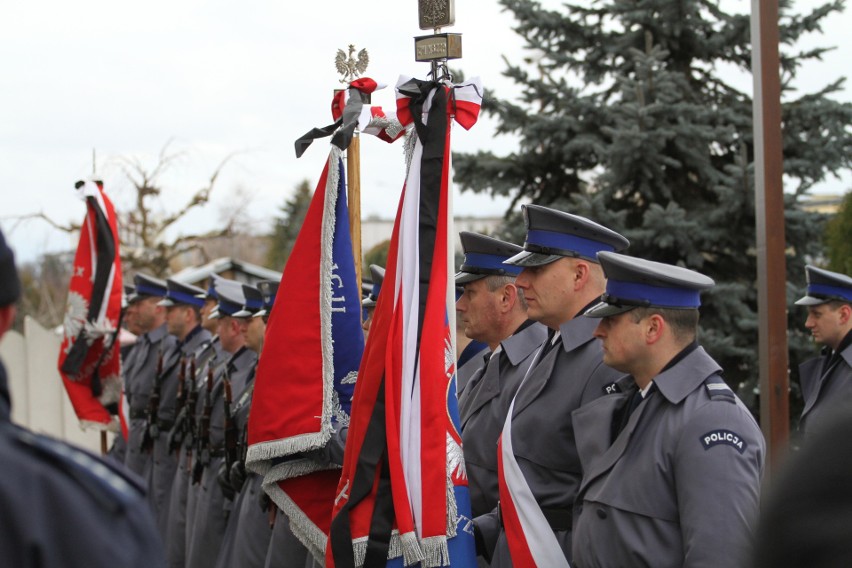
[751,0,790,473]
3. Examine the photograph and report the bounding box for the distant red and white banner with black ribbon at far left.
[58,182,122,431]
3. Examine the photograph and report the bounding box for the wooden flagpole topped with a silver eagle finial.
[335,43,369,310]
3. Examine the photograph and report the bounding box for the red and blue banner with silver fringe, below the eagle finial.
[247,147,364,558]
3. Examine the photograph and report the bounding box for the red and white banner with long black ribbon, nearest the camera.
[326,76,482,568]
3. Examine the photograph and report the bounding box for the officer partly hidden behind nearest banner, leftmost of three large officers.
[456,232,547,516]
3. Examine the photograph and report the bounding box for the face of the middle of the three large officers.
[515,258,574,329]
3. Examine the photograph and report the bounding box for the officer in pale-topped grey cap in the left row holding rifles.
[186,279,257,568]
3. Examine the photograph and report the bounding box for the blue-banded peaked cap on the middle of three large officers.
[506,205,630,267]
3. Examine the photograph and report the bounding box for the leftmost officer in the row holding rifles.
[124,274,177,479]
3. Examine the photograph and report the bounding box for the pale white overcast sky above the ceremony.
[0,0,852,260]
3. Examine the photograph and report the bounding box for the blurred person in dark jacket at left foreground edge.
[0,232,165,568]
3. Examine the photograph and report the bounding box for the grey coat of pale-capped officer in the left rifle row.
[186,348,257,568]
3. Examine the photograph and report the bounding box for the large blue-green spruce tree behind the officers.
[454,0,852,413]
